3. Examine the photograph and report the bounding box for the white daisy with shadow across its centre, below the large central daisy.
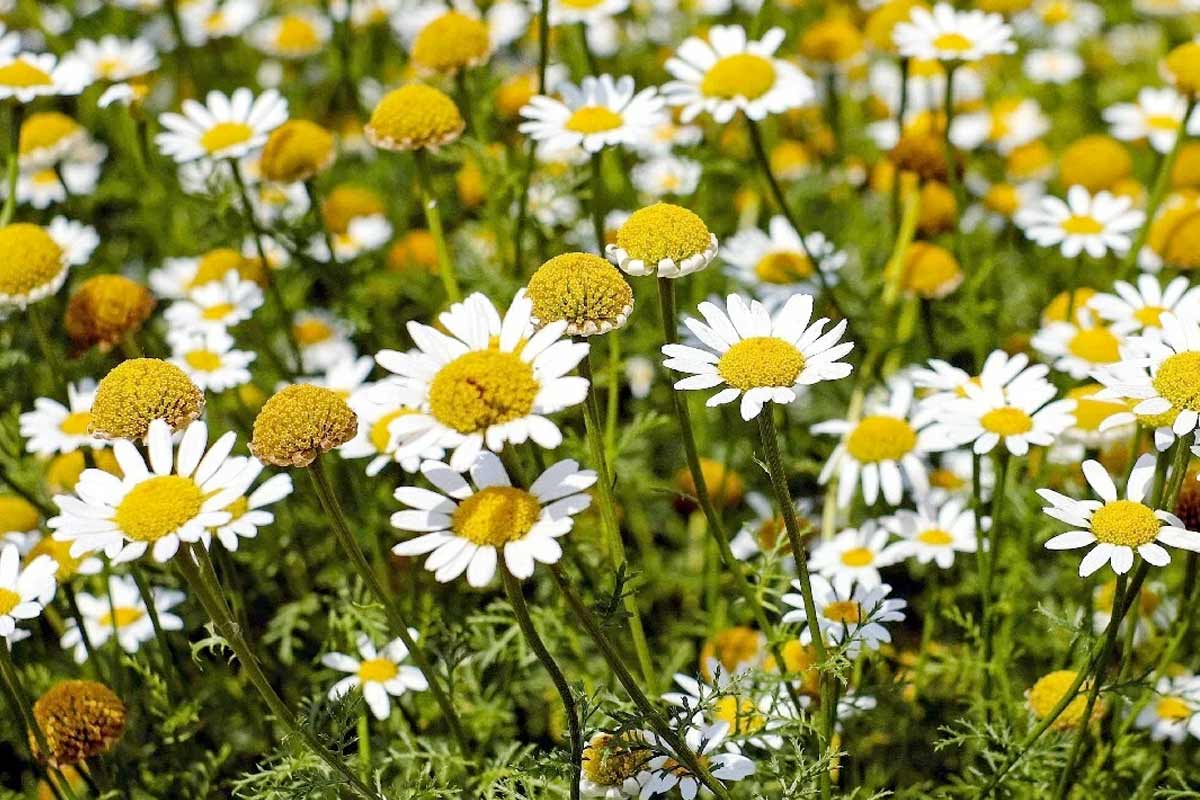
[391,451,596,588]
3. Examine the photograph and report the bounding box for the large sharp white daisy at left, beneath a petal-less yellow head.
[49,420,253,564]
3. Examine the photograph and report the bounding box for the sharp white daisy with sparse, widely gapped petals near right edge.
[1038,455,1200,578]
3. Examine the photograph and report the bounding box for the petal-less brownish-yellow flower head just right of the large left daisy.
[250,384,359,467]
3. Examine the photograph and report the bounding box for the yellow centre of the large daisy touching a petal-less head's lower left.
[430,350,540,433]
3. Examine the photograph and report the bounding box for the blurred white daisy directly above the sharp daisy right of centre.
[721,215,846,303]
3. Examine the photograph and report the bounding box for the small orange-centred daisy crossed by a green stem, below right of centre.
[782,575,908,658]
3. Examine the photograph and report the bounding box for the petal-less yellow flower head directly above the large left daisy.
[88,359,204,439]
